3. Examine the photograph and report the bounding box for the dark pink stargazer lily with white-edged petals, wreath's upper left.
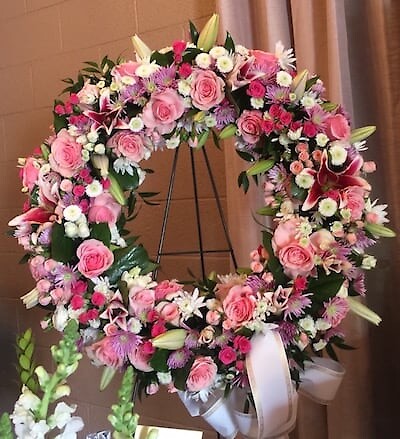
[83,89,128,135]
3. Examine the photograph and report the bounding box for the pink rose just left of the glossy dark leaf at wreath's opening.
[76,239,114,279]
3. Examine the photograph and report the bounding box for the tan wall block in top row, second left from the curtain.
[60,0,136,50]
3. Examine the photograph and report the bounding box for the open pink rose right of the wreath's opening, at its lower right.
[278,242,314,279]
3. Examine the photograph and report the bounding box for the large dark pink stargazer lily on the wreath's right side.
[302,150,371,211]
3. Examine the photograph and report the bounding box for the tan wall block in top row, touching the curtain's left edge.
[136,0,215,33]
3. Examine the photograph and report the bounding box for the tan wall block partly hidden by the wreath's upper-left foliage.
[32,47,99,107]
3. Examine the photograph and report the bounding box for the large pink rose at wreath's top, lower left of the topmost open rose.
[142,88,185,134]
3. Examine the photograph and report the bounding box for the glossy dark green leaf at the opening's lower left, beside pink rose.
[104,245,150,284]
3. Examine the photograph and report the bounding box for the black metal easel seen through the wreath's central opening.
[153,146,237,280]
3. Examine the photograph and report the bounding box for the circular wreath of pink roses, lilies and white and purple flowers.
[9,13,393,439]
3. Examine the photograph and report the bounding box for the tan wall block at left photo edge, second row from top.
[0,64,33,114]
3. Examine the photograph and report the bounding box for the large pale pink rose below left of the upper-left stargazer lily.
[49,128,85,178]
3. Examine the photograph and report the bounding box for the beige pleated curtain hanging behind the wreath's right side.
[217,0,400,439]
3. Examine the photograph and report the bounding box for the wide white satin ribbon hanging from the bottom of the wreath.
[178,329,344,439]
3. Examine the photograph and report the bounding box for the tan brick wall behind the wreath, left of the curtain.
[0,0,228,437]
